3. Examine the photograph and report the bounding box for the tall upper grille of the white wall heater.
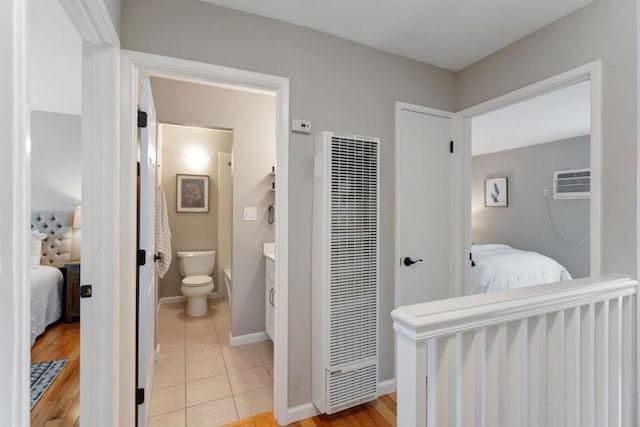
[329,136,378,368]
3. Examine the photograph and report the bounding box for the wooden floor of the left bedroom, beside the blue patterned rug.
[31,322,80,427]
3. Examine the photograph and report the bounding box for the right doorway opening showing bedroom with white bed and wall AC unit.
[467,80,591,294]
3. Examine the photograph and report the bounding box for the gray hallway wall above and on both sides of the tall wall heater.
[121,0,454,407]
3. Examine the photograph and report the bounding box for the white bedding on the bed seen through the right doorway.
[470,245,571,294]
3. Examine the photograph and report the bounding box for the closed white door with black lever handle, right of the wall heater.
[395,108,453,307]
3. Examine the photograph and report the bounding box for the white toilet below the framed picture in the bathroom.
[178,251,216,317]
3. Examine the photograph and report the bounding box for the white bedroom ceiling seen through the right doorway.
[471,81,591,156]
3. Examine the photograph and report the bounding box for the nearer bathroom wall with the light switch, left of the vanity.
[151,78,278,336]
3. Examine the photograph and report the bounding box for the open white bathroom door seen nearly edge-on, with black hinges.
[137,76,157,427]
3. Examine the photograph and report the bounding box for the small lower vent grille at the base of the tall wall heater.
[328,364,378,413]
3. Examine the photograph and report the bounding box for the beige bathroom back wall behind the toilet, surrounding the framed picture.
[158,122,233,298]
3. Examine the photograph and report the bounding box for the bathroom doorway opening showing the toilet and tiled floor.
[124,52,288,422]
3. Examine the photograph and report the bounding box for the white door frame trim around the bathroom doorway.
[122,50,289,425]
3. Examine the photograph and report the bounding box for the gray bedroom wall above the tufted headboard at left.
[31,111,82,212]
